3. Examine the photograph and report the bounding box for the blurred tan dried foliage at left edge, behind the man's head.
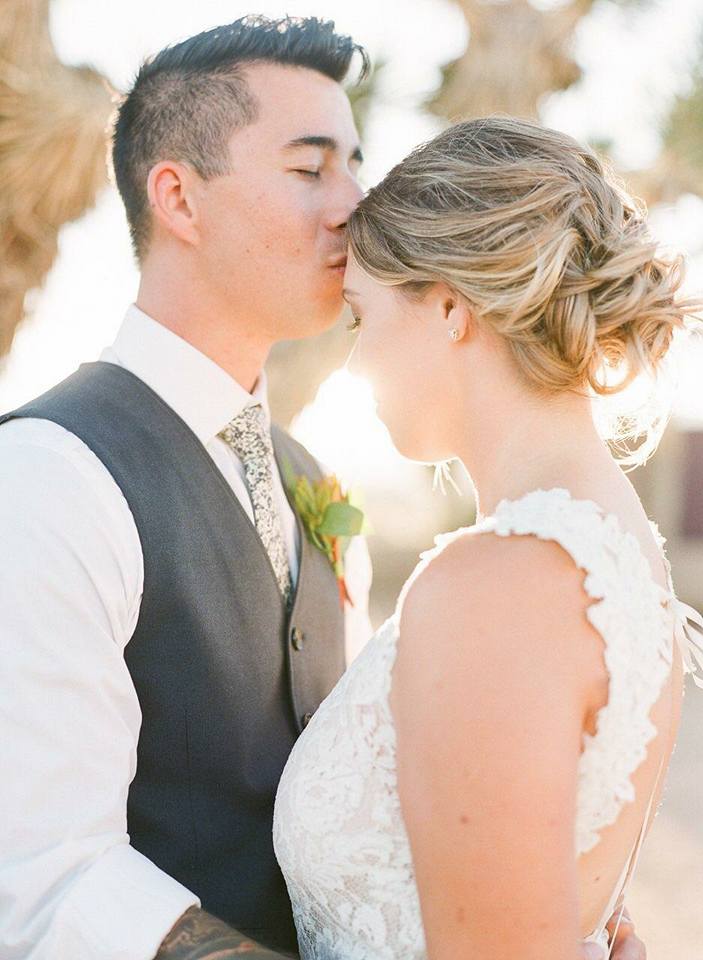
[0,0,112,357]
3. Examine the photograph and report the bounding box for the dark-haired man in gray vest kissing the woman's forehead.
[0,18,644,960]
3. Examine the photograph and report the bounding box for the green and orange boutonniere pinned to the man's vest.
[284,464,364,607]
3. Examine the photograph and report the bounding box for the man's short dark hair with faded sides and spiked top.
[112,16,369,260]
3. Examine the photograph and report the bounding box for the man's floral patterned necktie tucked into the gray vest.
[219,404,293,606]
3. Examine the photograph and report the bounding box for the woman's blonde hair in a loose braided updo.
[349,117,698,462]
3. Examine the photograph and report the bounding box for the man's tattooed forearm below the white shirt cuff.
[154,907,292,960]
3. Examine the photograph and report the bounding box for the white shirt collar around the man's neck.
[100,304,271,444]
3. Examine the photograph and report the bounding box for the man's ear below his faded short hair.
[147,160,199,244]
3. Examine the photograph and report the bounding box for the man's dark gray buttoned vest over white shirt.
[0,363,344,952]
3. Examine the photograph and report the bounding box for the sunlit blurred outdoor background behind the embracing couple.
[0,0,703,960]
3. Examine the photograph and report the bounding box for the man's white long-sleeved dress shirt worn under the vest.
[0,306,371,960]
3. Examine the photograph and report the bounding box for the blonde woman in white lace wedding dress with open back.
[274,118,703,960]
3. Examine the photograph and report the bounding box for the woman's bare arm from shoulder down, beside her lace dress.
[392,535,604,960]
